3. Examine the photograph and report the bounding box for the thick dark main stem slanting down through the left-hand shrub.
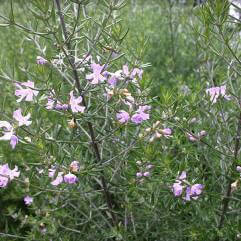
[55,0,117,226]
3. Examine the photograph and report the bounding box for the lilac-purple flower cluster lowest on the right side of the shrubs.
[172,171,204,201]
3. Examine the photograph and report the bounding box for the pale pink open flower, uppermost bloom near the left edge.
[15,81,39,102]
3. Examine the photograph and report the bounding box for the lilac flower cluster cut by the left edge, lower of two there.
[0,164,20,188]
